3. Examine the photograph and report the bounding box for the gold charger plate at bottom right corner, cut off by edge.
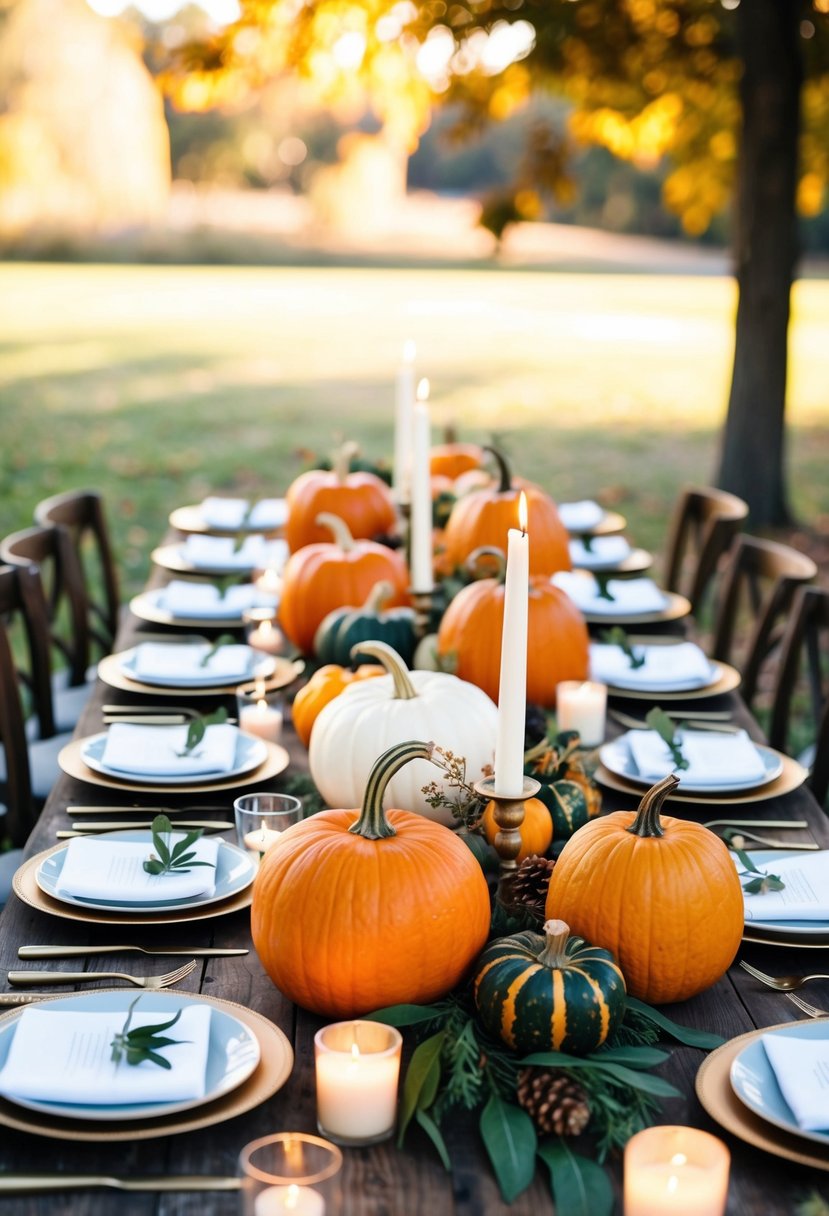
[695,1021,829,1170]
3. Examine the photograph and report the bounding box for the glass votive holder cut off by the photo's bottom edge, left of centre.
[239,1132,343,1216]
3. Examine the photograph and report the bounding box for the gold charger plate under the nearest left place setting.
[0,989,294,1143]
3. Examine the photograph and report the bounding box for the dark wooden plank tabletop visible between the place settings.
[0,576,829,1216]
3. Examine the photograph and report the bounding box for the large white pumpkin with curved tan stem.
[308,642,498,826]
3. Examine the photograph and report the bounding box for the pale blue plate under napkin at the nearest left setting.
[0,989,260,1122]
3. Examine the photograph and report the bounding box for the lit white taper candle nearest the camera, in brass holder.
[495,492,530,798]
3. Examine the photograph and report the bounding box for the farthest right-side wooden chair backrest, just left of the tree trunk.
[665,485,749,613]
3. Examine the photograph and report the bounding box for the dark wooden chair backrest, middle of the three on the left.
[0,527,91,685]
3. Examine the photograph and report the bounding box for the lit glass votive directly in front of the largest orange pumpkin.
[314,1021,402,1145]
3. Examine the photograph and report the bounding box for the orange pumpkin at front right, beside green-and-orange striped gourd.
[547,773,744,1004]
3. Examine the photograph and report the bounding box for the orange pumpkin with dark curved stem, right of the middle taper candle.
[446,449,573,576]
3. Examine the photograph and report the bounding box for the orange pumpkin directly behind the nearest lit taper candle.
[438,544,590,705]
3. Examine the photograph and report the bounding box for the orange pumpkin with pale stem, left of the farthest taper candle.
[284,444,396,553]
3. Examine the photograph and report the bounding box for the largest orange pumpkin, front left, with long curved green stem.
[250,743,490,1018]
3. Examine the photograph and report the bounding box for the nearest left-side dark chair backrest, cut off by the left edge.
[0,565,35,845]
